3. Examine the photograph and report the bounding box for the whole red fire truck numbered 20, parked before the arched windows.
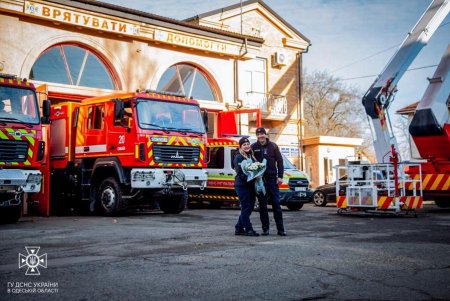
[49,92,207,215]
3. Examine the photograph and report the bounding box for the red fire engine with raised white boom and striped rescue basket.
[336,0,450,214]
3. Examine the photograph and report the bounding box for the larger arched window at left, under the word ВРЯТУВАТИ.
[29,45,117,90]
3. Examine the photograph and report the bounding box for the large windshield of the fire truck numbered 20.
[136,98,205,133]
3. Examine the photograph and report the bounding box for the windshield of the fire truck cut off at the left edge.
[0,86,39,124]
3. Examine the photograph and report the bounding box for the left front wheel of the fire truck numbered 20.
[97,178,124,215]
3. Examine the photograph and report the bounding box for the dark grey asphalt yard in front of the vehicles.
[0,204,450,300]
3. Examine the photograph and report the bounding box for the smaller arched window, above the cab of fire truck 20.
[157,64,218,101]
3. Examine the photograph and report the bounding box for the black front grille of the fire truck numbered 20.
[153,145,200,164]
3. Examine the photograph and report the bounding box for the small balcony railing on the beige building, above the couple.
[244,91,288,115]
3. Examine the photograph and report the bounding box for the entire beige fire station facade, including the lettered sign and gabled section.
[0,0,310,167]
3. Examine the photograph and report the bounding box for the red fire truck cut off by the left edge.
[0,74,50,223]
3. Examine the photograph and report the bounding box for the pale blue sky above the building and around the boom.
[102,0,450,115]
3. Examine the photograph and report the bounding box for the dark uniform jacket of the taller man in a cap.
[252,139,284,178]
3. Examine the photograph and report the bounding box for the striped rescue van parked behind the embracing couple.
[189,138,312,210]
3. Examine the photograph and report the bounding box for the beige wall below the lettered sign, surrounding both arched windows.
[0,6,234,110]
